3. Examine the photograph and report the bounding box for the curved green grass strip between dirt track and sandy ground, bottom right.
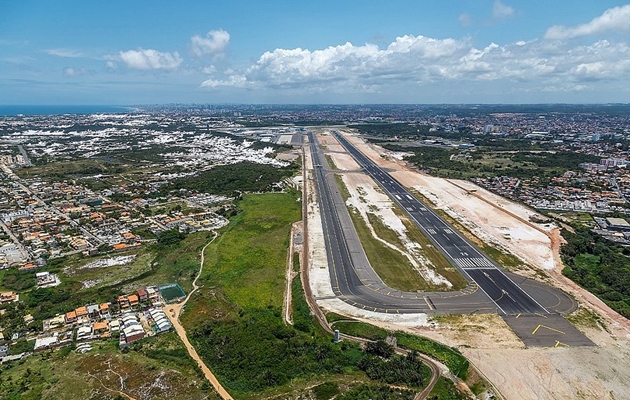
[394,332,470,380]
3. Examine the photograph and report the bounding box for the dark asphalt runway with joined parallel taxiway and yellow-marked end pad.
[308,132,592,346]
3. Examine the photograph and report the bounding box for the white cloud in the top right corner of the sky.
[545,4,630,40]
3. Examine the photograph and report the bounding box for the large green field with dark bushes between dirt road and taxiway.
[182,194,450,399]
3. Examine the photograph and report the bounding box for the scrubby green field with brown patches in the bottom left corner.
[0,333,218,400]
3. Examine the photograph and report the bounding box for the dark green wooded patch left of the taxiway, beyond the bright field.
[165,162,297,197]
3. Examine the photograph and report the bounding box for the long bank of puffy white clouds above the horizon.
[200,35,630,93]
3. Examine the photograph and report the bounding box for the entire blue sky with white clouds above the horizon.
[0,0,630,105]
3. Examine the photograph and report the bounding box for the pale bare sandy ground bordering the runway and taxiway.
[308,130,630,400]
